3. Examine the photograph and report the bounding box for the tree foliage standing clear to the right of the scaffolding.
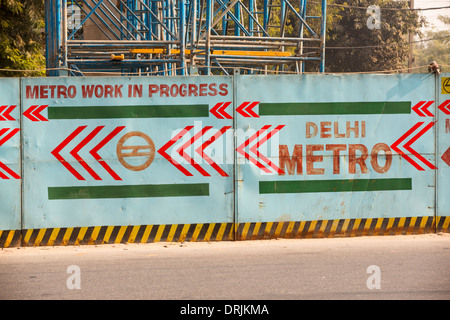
[326,0,425,72]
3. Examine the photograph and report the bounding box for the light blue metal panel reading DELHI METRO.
[236,74,435,223]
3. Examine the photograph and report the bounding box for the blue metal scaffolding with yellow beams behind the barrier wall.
[46,0,327,76]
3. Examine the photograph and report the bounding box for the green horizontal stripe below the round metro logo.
[48,183,209,200]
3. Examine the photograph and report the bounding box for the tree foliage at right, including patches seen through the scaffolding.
[253,0,425,72]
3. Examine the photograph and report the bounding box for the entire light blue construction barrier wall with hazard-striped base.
[0,74,450,247]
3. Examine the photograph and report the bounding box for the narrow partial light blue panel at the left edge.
[0,78,21,230]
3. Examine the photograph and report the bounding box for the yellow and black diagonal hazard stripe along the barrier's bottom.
[0,216,450,248]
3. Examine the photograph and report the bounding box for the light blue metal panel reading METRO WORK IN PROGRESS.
[22,77,234,229]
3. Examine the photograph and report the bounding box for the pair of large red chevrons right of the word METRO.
[391,122,436,171]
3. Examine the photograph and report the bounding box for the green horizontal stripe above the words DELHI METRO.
[259,101,411,116]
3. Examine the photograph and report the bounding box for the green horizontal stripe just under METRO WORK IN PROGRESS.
[48,104,209,120]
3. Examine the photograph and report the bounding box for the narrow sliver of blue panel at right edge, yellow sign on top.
[436,73,450,226]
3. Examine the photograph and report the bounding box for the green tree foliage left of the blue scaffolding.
[0,0,45,76]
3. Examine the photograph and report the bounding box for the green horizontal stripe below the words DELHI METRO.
[259,178,412,194]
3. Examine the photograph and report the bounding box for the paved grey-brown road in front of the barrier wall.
[0,234,450,300]
